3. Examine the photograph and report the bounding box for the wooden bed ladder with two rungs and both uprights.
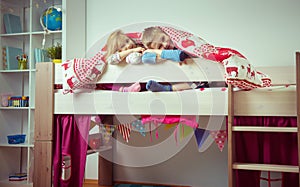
[228,52,300,187]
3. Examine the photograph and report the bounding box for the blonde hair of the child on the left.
[105,30,135,58]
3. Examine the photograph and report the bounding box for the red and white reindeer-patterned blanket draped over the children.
[62,26,271,93]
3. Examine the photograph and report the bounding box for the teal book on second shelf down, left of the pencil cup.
[3,46,23,70]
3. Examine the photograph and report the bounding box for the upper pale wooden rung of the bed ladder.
[232,126,298,132]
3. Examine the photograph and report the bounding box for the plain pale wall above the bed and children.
[86,0,300,66]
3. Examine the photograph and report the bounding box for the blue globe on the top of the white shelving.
[40,7,62,31]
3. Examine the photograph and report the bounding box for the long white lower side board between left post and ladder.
[55,88,227,115]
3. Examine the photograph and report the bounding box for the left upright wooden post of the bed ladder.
[227,84,235,187]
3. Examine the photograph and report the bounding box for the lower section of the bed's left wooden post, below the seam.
[33,141,52,187]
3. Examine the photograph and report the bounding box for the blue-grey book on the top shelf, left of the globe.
[3,14,22,34]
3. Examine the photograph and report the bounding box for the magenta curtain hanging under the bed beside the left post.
[53,115,91,187]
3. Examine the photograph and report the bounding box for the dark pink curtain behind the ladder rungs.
[230,116,299,187]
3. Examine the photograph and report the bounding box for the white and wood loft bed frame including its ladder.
[33,52,300,187]
